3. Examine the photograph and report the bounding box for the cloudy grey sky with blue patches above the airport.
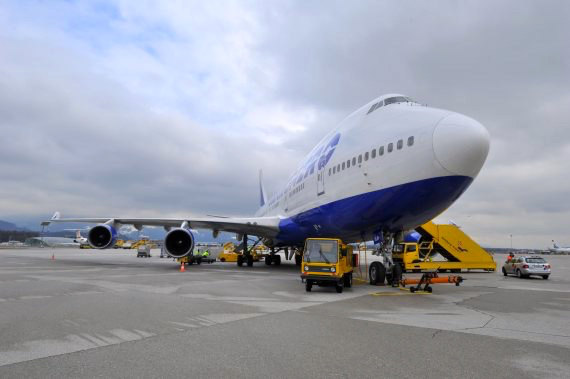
[0,0,570,248]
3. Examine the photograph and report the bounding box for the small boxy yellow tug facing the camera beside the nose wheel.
[301,238,355,293]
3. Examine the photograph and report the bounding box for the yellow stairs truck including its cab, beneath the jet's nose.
[392,221,497,272]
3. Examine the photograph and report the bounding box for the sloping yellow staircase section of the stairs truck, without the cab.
[410,221,497,271]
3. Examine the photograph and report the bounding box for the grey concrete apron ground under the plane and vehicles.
[0,248,570,378]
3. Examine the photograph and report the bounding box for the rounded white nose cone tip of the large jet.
[433,113,490,178]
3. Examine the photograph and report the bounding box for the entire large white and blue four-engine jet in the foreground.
[44,94,489,264]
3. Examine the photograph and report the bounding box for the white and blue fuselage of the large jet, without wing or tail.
[257,95,489,245]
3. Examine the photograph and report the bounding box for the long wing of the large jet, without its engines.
[41,212,281,237]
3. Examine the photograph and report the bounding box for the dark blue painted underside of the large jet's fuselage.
[276,176,473,246]
